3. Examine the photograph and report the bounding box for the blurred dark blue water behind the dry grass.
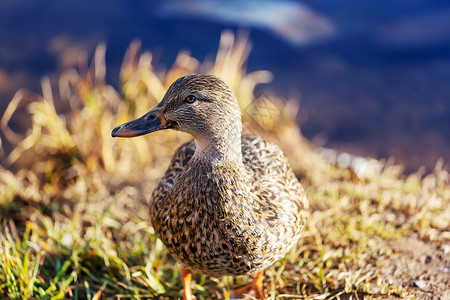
[0,0,450,172]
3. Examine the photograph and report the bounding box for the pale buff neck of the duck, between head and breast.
[194,122,243,165]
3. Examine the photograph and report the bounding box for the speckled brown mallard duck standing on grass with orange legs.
[112,74,308,300]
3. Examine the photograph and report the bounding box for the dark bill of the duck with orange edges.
[111,107,172,137]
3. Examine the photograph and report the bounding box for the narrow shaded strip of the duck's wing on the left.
[150,140,195,210]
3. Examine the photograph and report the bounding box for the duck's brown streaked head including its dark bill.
[112,74,242,157]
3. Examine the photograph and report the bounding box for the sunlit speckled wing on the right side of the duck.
[242,135,308,255]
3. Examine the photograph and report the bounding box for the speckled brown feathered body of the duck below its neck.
[150,135,308,276]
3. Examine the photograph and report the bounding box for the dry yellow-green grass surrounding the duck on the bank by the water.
[0,33,450,299]
